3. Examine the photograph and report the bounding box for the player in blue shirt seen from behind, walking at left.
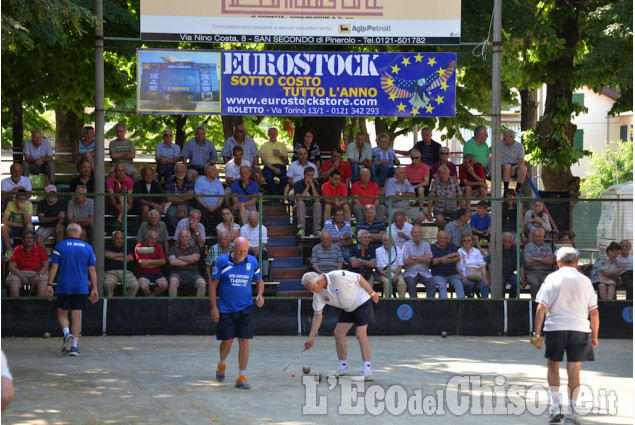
[46,223,99,356]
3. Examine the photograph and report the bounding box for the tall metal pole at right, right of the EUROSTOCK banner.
[490,0,505,298]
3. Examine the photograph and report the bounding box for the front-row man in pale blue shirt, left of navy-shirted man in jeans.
[402,224,434,298]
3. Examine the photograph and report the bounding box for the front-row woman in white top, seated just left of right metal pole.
[456,232,490,298]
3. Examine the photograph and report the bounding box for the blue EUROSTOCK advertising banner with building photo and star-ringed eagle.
[138,49,456,117]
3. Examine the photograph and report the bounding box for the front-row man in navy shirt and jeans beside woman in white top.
[430,230,465,298]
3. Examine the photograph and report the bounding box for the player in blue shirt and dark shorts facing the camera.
[209,236,265,389]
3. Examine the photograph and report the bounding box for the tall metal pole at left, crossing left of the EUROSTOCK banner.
[93,0,105,297]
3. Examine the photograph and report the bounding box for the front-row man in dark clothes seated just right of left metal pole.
[104,230,139,297]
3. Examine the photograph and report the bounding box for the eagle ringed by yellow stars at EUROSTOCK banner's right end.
[381,53,456,117]
